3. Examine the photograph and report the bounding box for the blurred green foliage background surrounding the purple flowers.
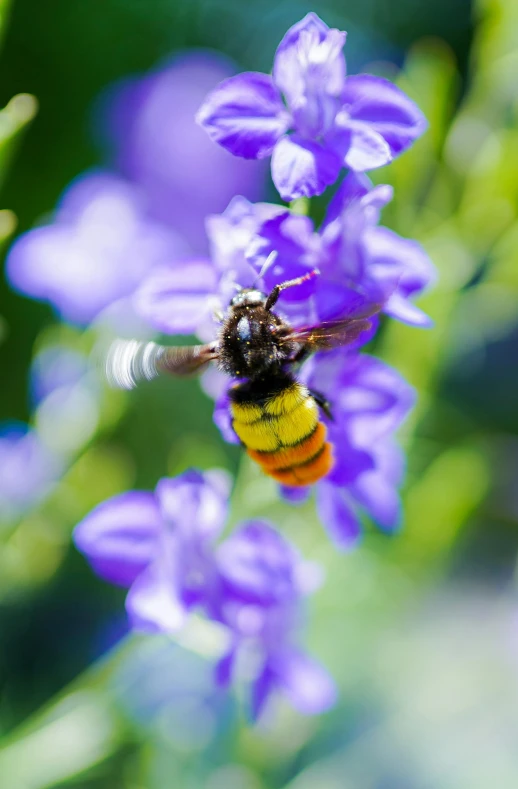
[0,0,518,789]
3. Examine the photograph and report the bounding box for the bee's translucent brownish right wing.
[282,304,383,353]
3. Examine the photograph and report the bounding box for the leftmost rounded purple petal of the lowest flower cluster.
[74,491,162,586]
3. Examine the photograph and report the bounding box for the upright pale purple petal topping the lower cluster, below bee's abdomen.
[156,470,230,541]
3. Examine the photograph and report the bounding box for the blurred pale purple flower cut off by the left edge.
[0,422,61,523]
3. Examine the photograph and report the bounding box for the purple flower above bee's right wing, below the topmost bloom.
[250,173,435,326]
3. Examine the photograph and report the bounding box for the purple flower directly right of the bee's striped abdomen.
[296,350,415,549]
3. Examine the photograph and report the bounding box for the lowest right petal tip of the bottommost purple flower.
[275,650,337,715]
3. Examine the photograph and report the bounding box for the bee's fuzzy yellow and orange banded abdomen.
[230,381,333,487]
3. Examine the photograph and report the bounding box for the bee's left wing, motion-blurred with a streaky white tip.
[105,340,218,389]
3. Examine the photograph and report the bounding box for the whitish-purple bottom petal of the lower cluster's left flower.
[126,557,186,633]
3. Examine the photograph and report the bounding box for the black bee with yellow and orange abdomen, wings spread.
[106,272,382,487]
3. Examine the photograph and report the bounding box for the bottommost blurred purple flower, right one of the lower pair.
[217,521,336,720]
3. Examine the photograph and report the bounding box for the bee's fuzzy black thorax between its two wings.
[219,305,298,378]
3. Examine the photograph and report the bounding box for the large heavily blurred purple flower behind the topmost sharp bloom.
[104,51,265,254]
